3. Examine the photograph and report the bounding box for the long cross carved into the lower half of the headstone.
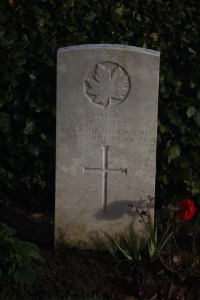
[83,146,127,212]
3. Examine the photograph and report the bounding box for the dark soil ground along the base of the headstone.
[0,205,200,300]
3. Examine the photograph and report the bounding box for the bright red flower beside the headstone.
[178,199,197,221]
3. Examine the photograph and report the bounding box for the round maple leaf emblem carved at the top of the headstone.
[85,62,130,108]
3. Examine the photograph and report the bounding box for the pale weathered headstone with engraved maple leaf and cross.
[55,45,159,247]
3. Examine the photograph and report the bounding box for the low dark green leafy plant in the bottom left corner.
[0,223,43,284]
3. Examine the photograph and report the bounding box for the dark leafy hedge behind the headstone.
[0,0,200,206]
